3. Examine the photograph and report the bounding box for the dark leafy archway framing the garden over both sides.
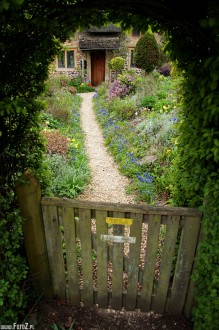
[0,0,219,330]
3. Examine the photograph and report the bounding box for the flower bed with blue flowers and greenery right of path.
[94,72,179,204]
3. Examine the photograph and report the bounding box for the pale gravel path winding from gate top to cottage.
[77,92,134,203]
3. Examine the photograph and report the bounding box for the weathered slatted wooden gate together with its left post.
[17,180,202,318]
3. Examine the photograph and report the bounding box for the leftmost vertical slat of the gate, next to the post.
[42,206,66,299]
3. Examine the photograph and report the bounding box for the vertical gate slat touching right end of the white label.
[126,214,143,311]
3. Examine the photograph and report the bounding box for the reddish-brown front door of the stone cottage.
[91,51,105,86]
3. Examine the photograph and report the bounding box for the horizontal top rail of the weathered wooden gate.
[41,197,202,217]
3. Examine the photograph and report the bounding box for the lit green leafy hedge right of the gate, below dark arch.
[166,18,219,330]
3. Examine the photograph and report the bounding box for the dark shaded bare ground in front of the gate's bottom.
[36,300,192,330]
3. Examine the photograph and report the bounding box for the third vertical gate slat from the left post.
[79,209,93,307]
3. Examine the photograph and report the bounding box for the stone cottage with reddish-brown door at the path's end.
[55,24,141,86]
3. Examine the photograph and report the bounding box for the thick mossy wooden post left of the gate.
[16,174,52,298]
